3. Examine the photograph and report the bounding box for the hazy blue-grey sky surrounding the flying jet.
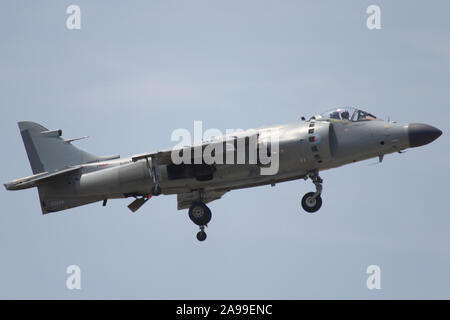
[0,0,450,299]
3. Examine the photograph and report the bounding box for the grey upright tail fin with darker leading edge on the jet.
[18,121,111,174]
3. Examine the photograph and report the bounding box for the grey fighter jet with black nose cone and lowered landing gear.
[5,108,442,241]
